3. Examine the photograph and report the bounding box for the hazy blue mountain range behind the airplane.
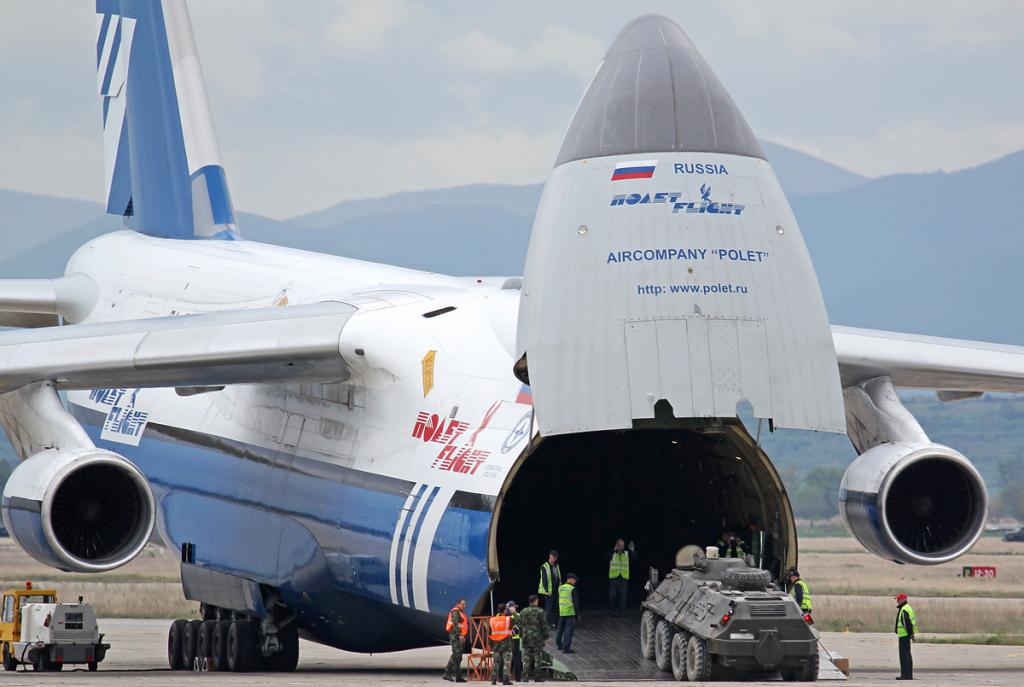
[0,143,1024,343]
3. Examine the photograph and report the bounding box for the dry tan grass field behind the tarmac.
[0,536,1024,643]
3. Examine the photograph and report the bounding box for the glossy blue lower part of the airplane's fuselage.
[71,404,494,651]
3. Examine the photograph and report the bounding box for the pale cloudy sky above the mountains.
[0,0,1024,217]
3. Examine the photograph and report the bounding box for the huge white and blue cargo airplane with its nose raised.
[0,0,1024,671]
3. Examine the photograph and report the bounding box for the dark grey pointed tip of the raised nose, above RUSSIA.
[555,14,765,167]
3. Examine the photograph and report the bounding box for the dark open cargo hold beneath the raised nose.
[487,421,797,613]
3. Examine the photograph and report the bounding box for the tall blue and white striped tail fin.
[96,0,239,240]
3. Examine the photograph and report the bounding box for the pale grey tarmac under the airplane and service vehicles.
[0,619,1024,687]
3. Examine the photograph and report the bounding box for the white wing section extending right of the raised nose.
[831,327,1024,399]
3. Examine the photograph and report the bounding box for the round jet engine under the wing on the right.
[839,443,988,565]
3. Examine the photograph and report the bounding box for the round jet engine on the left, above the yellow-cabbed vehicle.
[3,448,156,572]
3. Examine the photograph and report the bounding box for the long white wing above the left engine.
[0,303,355,392]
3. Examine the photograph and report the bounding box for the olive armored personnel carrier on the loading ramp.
[640,553,818,681]
